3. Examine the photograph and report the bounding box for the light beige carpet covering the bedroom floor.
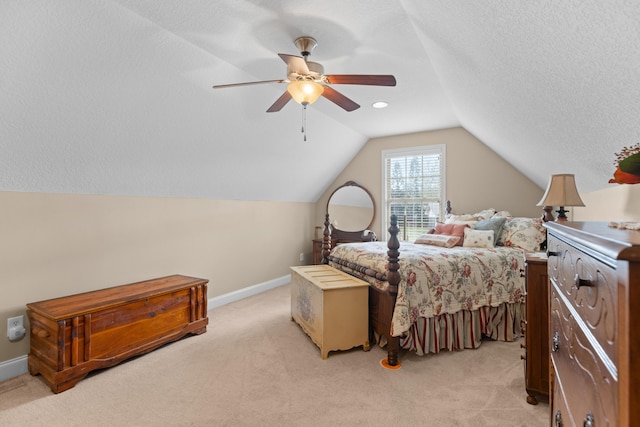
[0,285,550,427]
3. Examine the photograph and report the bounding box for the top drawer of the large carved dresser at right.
[547,235,618,365]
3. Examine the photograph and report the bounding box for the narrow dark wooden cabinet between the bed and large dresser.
[522,253,549,405]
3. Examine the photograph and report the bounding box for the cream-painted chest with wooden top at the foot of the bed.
[291,265,370,359]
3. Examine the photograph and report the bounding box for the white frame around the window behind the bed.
[380,144,447,241]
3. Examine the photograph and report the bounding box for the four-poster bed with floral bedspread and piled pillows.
[323,209,546,367]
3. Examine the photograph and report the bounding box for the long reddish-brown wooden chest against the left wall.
[27,275,208,393]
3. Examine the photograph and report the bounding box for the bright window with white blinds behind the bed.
[382,145,445,241]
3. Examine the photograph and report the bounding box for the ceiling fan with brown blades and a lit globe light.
[213,37,396,113]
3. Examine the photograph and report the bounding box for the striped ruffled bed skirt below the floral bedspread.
[376,303,524,356]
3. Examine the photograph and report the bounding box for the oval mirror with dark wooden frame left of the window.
[327,181,376,241]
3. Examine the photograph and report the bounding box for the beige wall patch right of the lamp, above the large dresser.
[567,184,640,221]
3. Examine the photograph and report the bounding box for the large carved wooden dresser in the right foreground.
[546,222,640,427]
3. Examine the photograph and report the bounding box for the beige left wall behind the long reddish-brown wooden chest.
[0,192,313,362]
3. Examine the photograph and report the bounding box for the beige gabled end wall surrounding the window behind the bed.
[313,128,544,236]
